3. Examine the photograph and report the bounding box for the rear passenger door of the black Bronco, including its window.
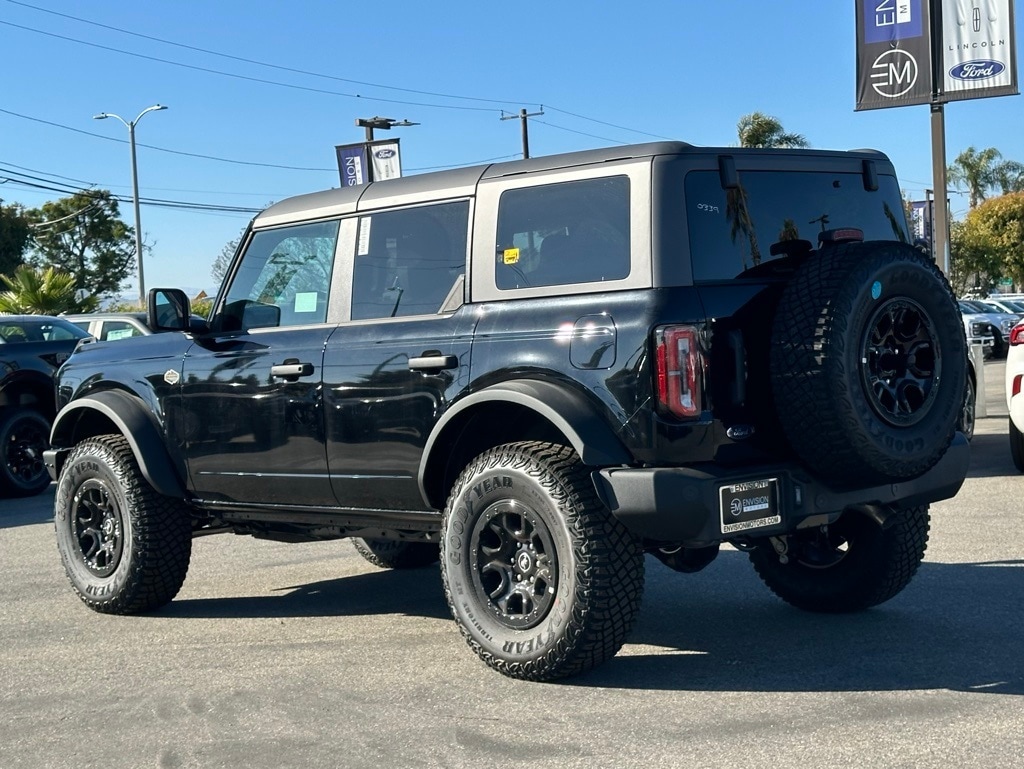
[324,200,473,511]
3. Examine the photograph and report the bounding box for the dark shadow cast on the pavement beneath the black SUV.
[163,551,1024,694]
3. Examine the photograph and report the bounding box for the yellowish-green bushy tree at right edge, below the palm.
[950,193,1024,289]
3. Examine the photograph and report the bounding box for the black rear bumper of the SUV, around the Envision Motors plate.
[594,433,971,547]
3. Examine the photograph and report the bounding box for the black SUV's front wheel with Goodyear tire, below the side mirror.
[53,435,191,614]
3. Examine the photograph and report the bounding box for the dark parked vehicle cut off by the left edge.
[0,315,89,497]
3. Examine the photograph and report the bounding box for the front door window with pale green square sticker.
[213,221,339,331]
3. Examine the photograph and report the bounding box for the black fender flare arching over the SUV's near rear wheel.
[418,379,634,501]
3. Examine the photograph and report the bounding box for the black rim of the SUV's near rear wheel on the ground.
[470,500,558,630]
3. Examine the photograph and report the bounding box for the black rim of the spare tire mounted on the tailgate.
[860,298,941,427]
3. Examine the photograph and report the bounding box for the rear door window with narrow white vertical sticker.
[352,201,469,321]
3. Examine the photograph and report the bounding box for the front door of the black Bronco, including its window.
[179,221,339,508]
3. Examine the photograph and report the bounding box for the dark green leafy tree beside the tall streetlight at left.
[28,189,135,297]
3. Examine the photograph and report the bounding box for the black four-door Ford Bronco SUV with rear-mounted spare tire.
[46,142,969,680]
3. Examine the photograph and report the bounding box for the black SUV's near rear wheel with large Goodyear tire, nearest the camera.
[440,442,644,681]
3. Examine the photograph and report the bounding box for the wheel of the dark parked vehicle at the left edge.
[0,408,50,497]
